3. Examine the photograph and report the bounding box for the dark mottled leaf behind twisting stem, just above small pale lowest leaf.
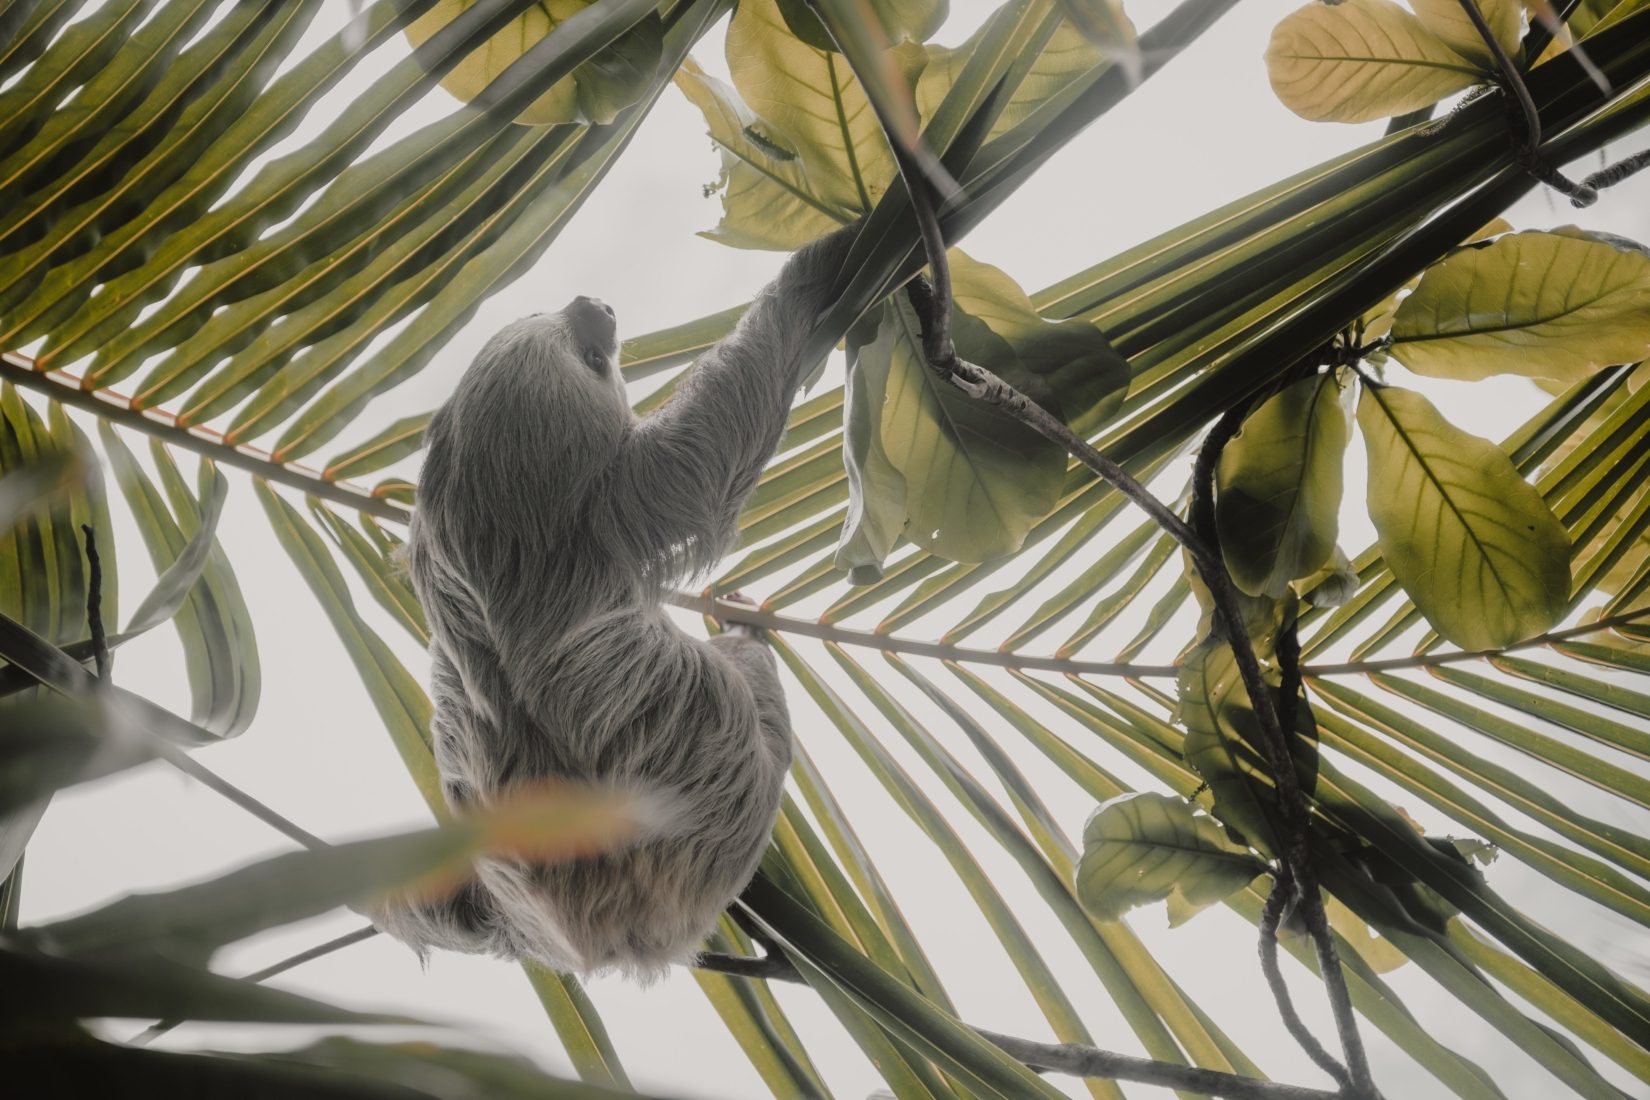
[1176,642,1318,854]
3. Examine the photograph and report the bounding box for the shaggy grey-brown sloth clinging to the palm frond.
[375,231,850,981]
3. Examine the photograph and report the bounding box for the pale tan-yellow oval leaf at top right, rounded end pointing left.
[1266,0,1488,122]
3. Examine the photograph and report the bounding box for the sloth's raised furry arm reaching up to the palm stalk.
[609,226,856,571]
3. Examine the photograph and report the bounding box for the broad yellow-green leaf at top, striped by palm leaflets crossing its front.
[406,0,663,125]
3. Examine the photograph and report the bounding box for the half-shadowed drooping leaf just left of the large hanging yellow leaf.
[1214,371,1351,597]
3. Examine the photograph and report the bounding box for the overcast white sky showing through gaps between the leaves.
[23,0,1650,1098]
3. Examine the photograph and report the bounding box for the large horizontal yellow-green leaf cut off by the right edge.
[1393,228,1650,386]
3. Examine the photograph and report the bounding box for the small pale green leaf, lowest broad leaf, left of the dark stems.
[1077,793,1266,920]
